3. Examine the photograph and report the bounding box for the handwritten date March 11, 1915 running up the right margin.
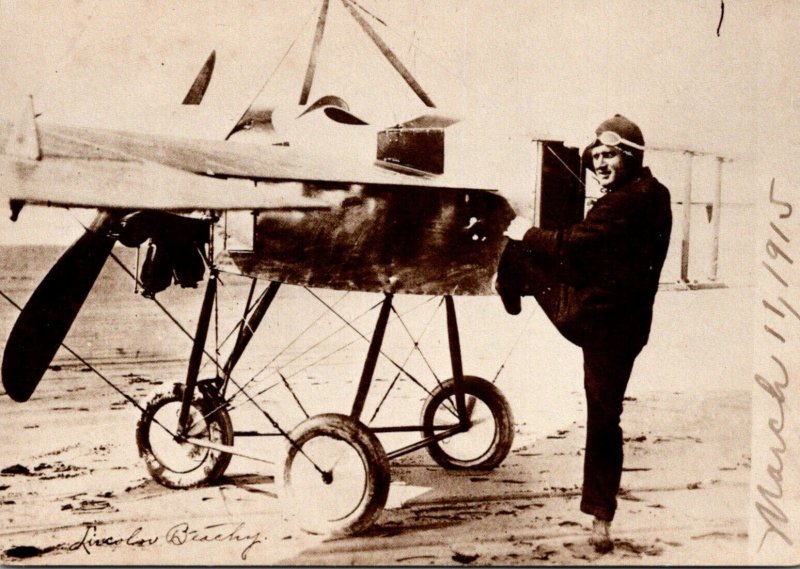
[755,179,800,550]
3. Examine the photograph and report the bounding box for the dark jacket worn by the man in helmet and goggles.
[522,168,672,347]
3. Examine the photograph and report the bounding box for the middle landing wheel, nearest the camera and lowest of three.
[284,413,390,534]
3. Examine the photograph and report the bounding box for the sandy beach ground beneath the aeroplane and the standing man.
[0,248,753,565]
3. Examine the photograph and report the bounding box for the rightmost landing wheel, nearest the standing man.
[422,376,514,470]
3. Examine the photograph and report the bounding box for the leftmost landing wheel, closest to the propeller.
[136,384,233,488]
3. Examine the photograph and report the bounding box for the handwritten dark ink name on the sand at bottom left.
[62,522,265,560]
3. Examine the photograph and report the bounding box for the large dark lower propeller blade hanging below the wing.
[2,213,115,402]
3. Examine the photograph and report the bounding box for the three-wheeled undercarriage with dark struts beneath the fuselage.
[137,278,514,534]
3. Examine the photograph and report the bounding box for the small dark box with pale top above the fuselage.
[376,115,458,174]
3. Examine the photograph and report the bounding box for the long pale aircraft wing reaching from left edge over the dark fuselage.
[0,114,496,216]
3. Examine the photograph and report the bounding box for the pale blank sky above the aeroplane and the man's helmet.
[0,0,800,242]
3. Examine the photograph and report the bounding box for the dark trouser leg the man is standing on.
[581,345,642,521]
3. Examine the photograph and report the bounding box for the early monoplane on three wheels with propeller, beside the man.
[0,0,583,533]
